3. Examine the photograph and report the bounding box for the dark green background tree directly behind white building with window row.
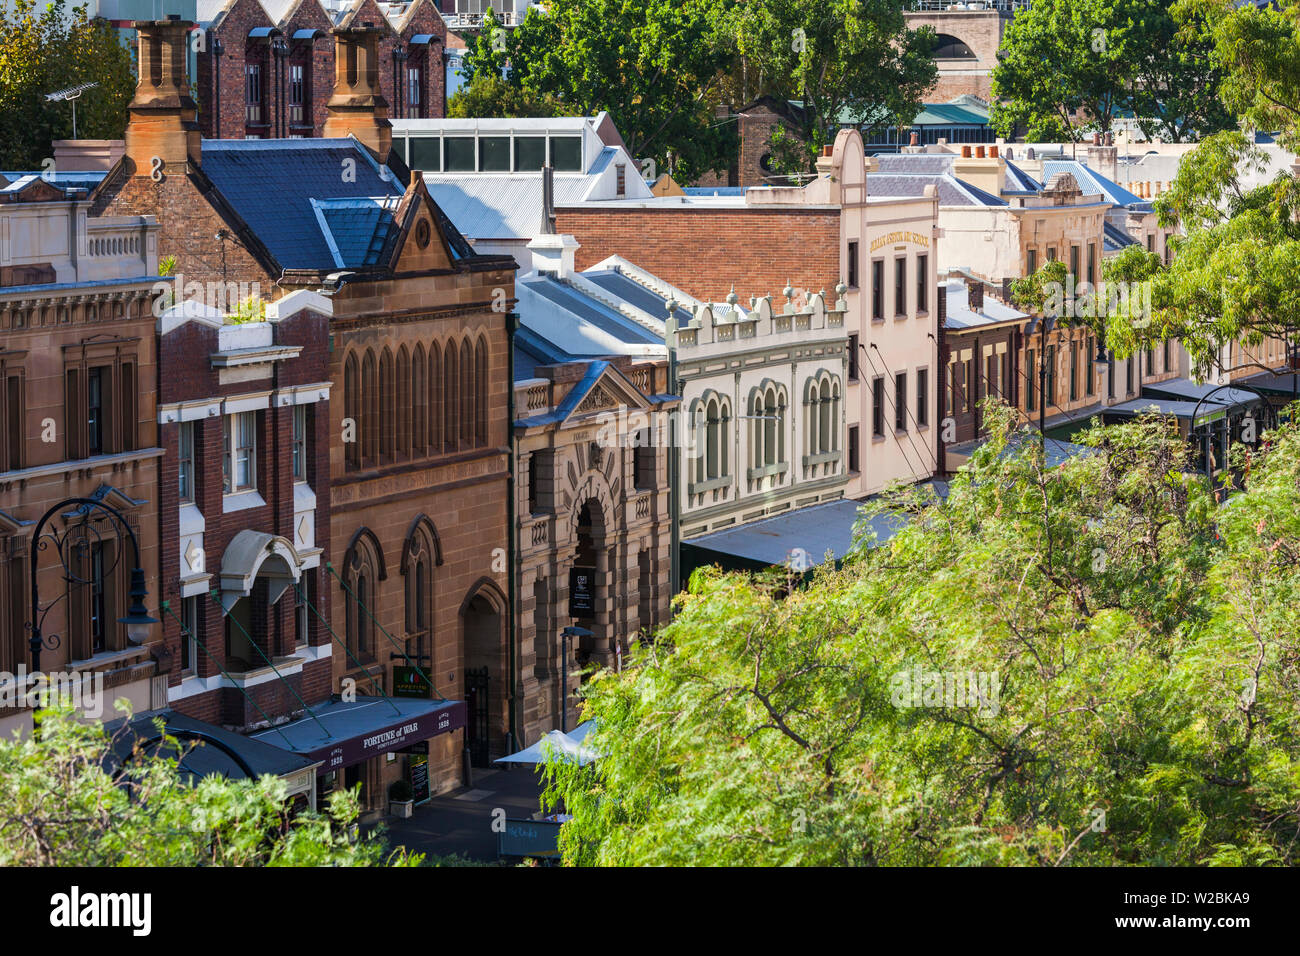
[508,0,736,181]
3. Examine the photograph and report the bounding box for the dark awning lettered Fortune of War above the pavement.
[252,697,465,774]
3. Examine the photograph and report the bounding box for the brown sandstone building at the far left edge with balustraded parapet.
[0,174,166,736]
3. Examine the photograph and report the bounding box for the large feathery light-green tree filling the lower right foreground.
[546,401,1300,865]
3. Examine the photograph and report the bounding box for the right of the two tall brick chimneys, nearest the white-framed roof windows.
[324,23,393,163]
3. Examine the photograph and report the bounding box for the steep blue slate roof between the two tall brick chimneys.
[203,139,403,271]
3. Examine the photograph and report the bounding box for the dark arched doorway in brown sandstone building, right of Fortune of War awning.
[460,581,511,766]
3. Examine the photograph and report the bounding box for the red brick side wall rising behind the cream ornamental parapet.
[555,204,840,302]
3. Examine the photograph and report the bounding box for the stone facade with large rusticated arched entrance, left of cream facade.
[515,345,677,744]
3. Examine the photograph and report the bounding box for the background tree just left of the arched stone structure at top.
[727,0,937,172]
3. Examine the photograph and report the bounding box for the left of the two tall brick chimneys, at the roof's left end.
[126,17,200,176]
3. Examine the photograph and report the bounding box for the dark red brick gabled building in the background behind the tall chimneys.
[192,0,447,139]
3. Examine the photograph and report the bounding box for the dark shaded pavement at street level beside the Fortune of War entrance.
[384,766,542,862]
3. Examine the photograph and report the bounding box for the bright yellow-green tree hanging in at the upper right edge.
[1118,0,1300,375]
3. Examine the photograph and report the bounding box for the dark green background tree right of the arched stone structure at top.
[991,0,1231,142]
